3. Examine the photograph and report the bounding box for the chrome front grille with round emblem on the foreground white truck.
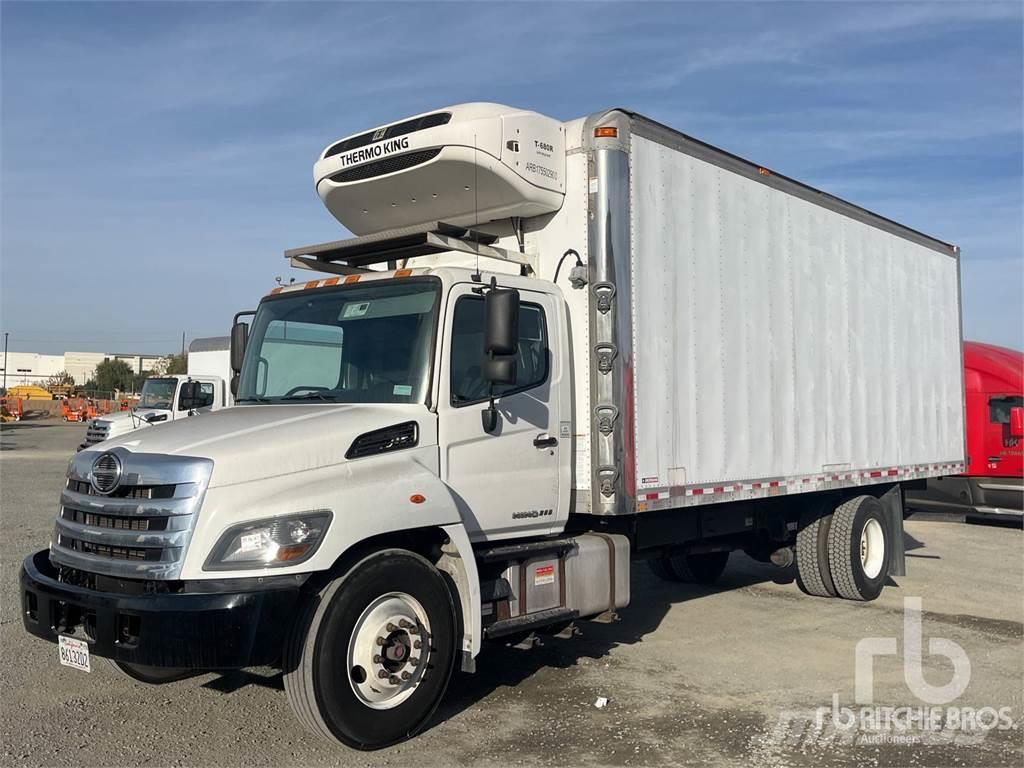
[50,447,213,580]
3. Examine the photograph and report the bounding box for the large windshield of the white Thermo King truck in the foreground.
[236,278,439,402]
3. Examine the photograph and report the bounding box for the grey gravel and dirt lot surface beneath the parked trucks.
[0,421,1024,766]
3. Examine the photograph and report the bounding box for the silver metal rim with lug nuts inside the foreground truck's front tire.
[347,592,430,710]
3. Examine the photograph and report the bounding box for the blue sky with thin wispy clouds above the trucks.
[0,0,1024,354]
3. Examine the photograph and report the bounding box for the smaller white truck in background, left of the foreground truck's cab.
[79,336,233,451]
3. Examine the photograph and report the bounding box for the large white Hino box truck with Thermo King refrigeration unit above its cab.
[20,103,965,749]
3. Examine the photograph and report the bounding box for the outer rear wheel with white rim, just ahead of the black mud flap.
[828,496,892,601]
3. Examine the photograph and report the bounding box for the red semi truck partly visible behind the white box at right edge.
[906,341,1024,521]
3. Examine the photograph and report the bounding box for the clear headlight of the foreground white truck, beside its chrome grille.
[203,510,331,570]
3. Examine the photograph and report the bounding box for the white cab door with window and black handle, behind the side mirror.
[437,284,571,541]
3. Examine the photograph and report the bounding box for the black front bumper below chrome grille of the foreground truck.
[19,550,308,670]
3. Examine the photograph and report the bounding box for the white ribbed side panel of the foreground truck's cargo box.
[631,133,965,508]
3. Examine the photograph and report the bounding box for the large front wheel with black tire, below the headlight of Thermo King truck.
[285,550,456,750]
